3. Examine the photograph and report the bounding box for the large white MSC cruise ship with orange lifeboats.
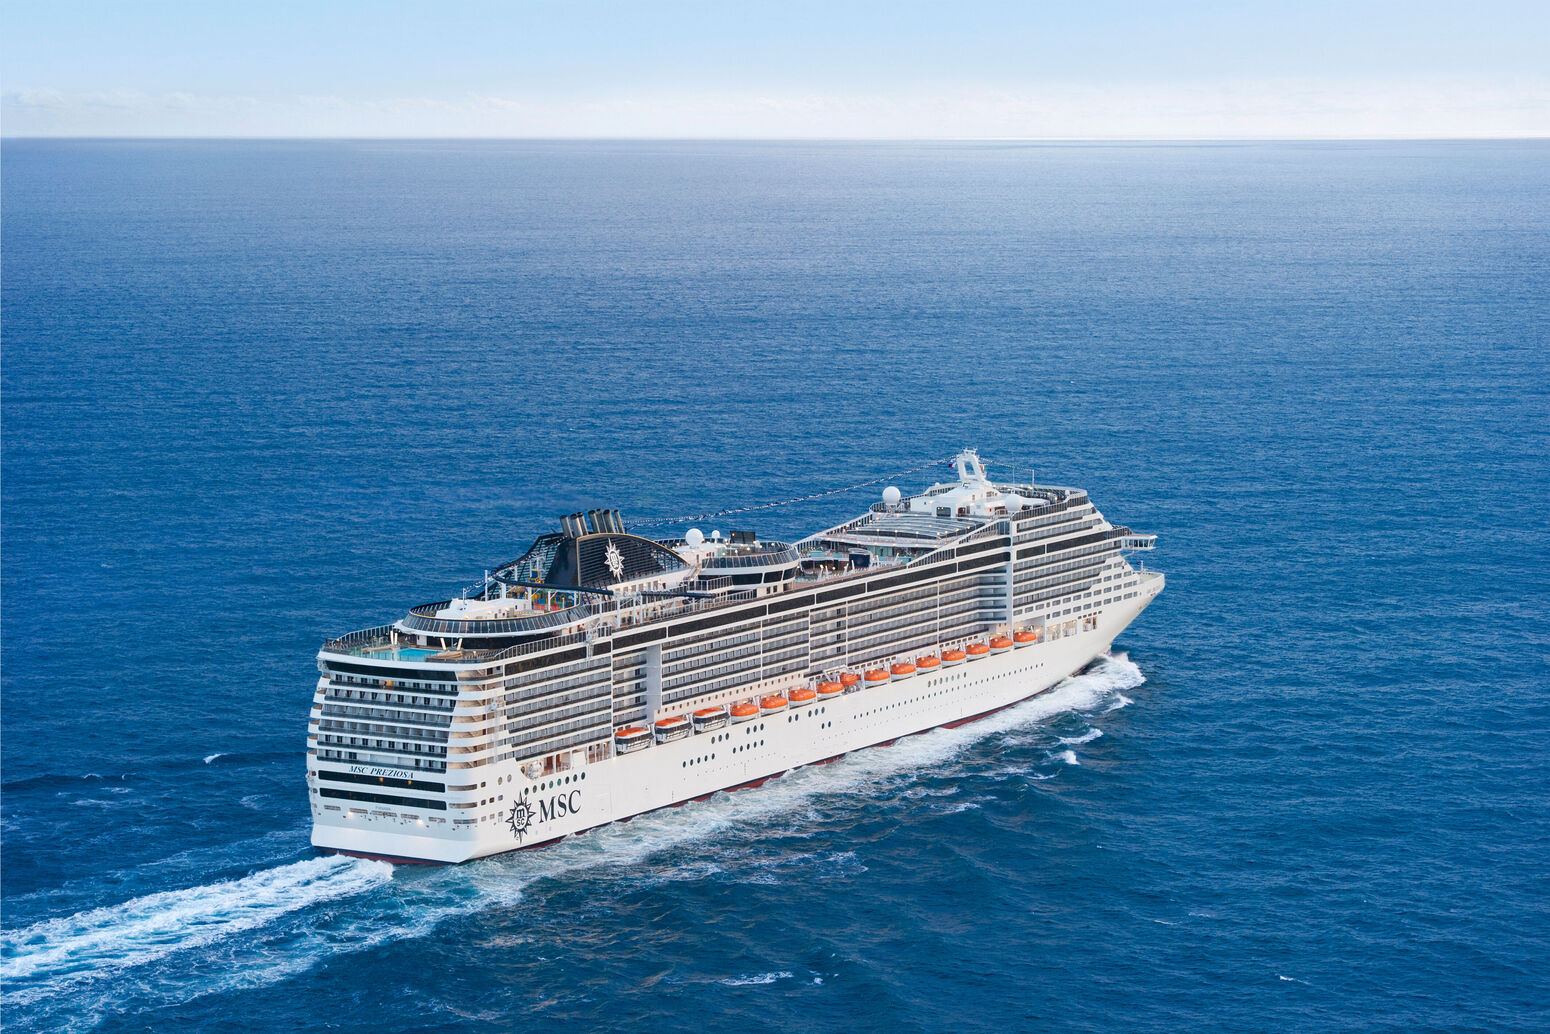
[307,451,1164,863]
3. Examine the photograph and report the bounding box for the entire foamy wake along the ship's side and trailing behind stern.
[0,654,1144,1031]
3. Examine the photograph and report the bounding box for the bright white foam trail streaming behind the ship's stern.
[0,857,392,1005]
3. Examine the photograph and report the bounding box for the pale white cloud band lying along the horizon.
[0,78,1550,140]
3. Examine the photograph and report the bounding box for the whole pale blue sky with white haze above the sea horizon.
[0,0,1550,140]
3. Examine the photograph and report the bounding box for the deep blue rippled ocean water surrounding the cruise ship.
[0,141,1550,1034]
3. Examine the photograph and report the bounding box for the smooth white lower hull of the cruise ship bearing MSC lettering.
[312,574,1164,862]
